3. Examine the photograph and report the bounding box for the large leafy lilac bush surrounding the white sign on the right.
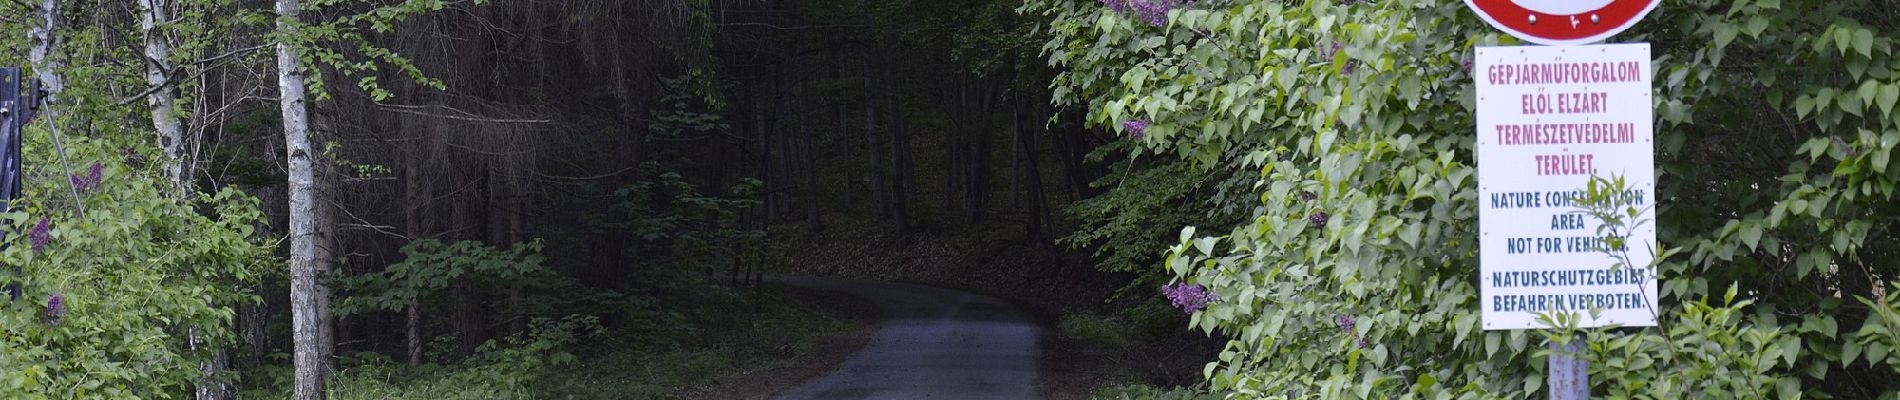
[1020,0,1900,398]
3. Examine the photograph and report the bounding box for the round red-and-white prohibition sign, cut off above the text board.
[1465,0,1661,45]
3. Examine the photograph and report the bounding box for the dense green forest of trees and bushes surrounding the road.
[0,0,1900,400]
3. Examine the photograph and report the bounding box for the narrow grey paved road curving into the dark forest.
[771,277,1039,400]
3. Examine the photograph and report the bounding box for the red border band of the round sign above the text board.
[1465,0,1661,44]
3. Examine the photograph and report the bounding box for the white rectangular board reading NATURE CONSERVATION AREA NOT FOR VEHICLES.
[1473,44,1657,330]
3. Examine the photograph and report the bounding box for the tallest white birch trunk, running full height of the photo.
[276,0,325,400]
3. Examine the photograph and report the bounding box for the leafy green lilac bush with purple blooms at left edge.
[0,133,283,398]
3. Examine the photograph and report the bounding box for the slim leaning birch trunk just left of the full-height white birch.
[139,0,192,199]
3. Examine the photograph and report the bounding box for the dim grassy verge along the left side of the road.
[298,290,861,400]
